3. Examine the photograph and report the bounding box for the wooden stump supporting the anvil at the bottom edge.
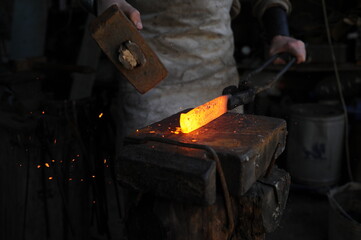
[128,168,290,240]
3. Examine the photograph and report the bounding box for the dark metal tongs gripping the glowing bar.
[222,53,296,110]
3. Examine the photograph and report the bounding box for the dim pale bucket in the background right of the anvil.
[287,103,345,187]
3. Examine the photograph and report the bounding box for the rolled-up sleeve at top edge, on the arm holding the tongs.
[252,0,292,21]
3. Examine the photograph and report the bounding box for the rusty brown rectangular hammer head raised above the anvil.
[91,5,168,93]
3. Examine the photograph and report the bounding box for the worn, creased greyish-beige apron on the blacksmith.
[119,0,238,134]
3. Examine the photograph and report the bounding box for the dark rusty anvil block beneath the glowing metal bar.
[118,113,287,204]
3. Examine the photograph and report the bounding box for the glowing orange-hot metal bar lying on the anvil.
[179,95,229,133]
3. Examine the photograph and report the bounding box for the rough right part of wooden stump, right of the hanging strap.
[235,167,291,240]
